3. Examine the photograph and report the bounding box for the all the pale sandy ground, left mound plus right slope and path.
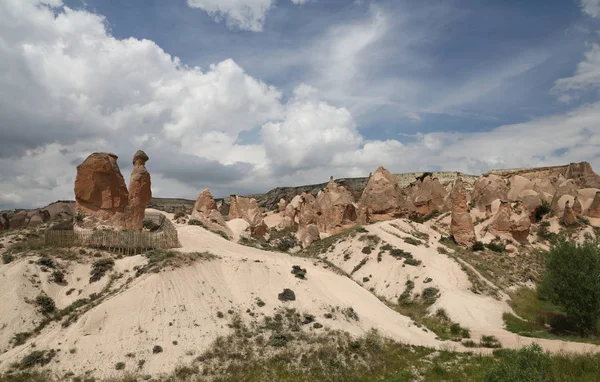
[0,214,598,377]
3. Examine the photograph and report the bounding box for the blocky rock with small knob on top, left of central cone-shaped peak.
[311,177,357,233]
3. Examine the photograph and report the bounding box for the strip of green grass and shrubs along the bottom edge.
[0,344,600,382]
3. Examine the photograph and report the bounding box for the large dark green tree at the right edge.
[540,238,600,336]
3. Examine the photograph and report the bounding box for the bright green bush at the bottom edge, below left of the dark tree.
[484,344,555,382]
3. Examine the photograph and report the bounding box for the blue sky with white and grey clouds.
[0,0,600,209]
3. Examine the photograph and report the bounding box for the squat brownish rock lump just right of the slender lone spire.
[488,200,531,243]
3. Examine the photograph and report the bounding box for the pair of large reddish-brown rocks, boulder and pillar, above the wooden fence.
[75,151,152,230]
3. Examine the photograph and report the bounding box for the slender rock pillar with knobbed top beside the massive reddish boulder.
[126,150,152,230]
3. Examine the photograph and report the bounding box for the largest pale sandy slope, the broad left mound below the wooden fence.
[0,212,446,377]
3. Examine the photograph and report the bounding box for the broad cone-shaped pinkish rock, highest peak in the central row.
[359,167,414,222]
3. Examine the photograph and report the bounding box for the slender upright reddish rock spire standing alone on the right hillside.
[450,177,476,246]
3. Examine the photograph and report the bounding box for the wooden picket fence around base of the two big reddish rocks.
[44,214,181,255]
